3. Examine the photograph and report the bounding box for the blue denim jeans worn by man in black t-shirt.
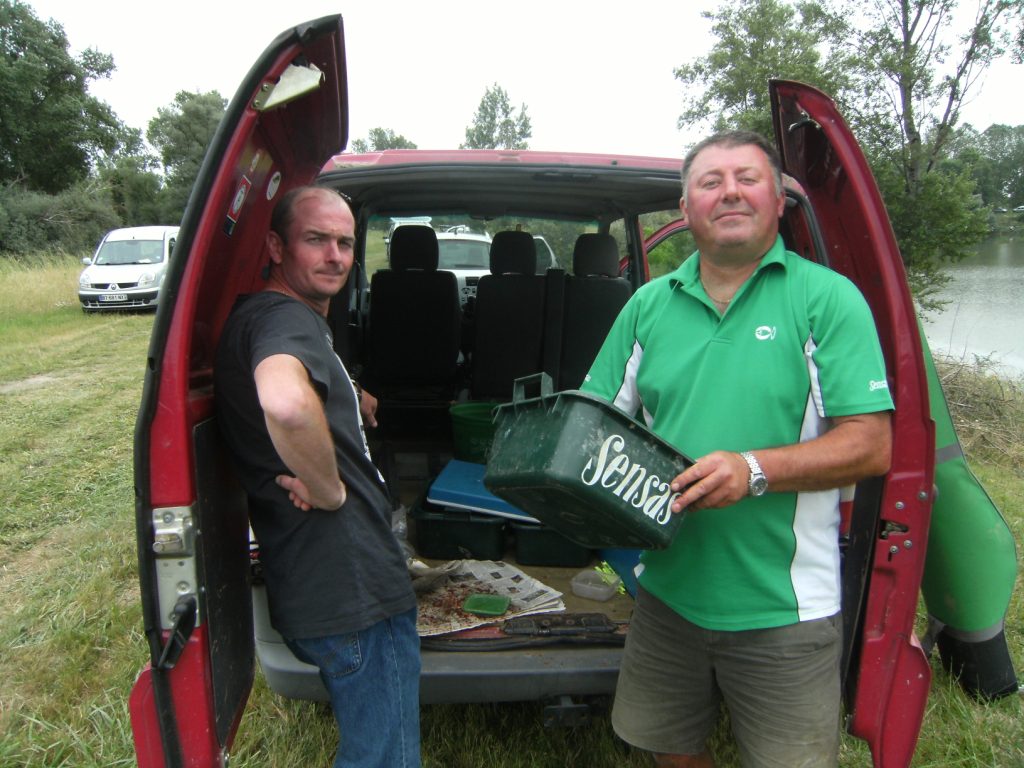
[285,608,420,768]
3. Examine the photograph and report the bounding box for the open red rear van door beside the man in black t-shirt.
[129,15,348,768]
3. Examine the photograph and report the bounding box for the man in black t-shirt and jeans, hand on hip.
[215,187,420,768]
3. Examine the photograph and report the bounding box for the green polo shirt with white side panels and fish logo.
[583,239,893,630]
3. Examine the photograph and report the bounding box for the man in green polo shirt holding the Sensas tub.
[583,132,893,768]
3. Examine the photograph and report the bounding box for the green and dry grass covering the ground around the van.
[0,258,1024,768]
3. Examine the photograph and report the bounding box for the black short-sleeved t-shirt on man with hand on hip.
[214,291,416,638]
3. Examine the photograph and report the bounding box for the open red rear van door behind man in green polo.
[770,81,935,768]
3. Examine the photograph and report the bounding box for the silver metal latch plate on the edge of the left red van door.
[153,507,202,630]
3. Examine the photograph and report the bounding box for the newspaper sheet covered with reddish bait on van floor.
[410,560,565,637]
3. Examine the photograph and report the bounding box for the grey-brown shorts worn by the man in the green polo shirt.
[611,588,843,768]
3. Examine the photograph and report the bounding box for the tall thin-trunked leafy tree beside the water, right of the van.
[858,0,1024,310]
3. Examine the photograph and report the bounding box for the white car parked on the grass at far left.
[78,226,178,312]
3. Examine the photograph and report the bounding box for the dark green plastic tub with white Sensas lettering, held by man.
[483,375,693,549]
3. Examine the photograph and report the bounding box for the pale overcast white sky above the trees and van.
[22,0,1024,157]
